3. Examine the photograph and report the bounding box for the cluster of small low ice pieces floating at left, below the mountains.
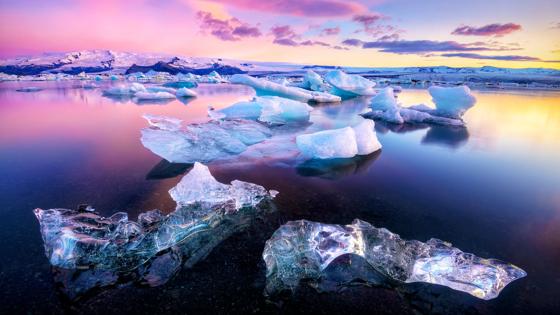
[103,82,196,100]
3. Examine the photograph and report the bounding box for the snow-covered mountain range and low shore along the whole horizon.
[0,50,560,81]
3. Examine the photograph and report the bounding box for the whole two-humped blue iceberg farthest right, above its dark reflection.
[363,85,476,126]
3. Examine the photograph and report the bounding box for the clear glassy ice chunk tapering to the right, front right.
[263,219,527,300]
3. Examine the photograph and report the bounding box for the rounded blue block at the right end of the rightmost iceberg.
[428,85,476,118]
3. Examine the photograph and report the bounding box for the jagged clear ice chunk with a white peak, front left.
[34,163,277,297]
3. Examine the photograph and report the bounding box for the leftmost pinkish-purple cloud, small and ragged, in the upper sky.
[196,11,262,41]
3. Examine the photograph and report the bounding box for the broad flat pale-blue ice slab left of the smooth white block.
[141,115,271,163]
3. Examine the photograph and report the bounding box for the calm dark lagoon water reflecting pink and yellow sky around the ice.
[0,82,560,314]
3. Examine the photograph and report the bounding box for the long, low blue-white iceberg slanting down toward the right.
[230,74,341,103]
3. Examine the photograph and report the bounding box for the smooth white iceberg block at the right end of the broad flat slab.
[296,120,381,159]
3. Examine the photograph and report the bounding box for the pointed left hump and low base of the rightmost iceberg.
[363,87,472,126]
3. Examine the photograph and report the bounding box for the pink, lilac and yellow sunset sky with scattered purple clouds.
[0,0,560,69]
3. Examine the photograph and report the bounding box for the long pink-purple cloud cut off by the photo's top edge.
[205,0,366,17]
